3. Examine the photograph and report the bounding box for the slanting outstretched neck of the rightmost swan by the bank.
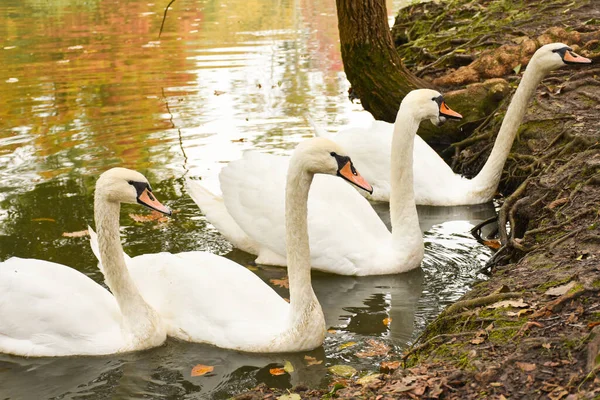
[473,60,545,192]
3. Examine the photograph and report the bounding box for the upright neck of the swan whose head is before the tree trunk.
[390,110,423,248]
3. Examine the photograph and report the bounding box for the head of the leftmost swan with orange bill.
[95,168,171,215]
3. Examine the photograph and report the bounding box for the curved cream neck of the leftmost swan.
[94,196,157,335]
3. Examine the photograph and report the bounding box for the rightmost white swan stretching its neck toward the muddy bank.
[309,43,591,206]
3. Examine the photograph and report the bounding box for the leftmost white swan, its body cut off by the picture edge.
[0,168,171,357]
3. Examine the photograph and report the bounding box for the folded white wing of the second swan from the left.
[129,251,289,348]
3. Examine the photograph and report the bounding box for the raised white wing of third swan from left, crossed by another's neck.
[220,153,389,275]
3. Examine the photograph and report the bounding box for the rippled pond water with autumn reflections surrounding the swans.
[0,0,494,399]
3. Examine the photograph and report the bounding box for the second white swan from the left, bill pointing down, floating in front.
[90,138,371,353]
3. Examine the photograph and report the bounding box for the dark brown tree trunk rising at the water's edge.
[336,0,431,122]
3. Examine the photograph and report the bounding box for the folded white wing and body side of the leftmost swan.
[0,257,123,356]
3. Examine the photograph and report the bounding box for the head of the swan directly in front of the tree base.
[400,89,462,126]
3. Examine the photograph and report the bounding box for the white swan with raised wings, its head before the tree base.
[187,89,460,275]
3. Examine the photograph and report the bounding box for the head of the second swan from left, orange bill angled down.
[290,138,373,193]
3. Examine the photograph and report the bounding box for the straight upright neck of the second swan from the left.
[285,157,318,325]
